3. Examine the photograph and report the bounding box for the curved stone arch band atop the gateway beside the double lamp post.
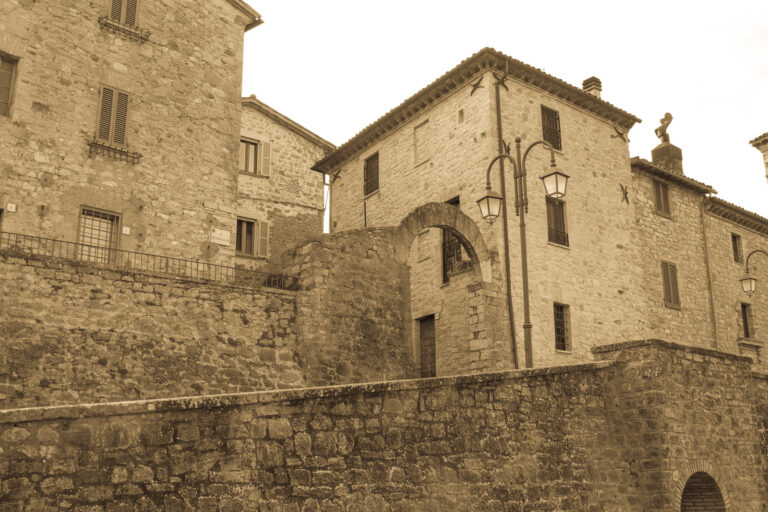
[396,203,492,283]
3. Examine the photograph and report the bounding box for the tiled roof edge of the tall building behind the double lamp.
[312,48,640,173]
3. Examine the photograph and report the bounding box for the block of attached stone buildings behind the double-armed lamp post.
[314,49,768,375]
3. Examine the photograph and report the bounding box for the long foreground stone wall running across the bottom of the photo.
[0,341,768,512]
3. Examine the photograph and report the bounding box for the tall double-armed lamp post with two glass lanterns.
[477,137,568,368]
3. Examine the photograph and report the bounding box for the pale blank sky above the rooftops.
[243,0,768,217]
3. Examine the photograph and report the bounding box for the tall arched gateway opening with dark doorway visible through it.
[400,201,506,378]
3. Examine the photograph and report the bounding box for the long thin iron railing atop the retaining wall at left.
[0,232,299,290]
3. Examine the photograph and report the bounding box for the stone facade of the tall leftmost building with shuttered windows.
[0,0,246,264]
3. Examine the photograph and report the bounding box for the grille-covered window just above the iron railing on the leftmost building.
[77,207,120,263]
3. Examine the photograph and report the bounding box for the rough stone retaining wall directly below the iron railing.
[0,251,305,408]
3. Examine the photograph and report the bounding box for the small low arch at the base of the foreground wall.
[673,462,730,512]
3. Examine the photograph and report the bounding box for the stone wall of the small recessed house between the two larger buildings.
[232,99,328,270]
